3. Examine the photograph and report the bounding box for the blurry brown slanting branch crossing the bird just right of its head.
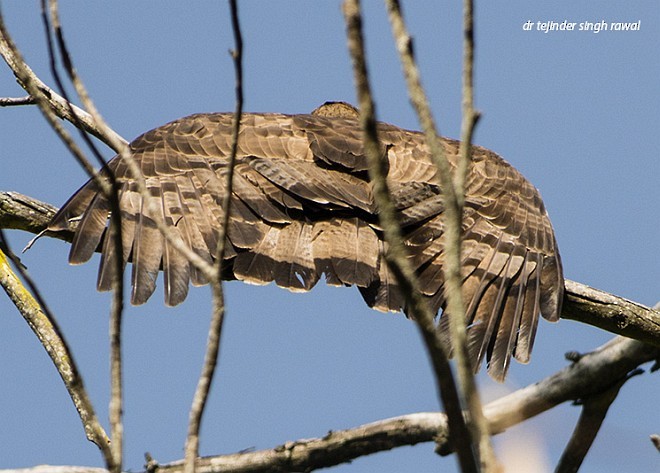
[343,0,478,472]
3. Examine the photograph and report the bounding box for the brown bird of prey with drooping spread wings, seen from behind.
[49,103,564,380]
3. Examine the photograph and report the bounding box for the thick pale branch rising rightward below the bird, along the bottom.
[0,337,660,473]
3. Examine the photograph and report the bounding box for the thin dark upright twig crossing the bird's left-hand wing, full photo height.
[184,0,243,473]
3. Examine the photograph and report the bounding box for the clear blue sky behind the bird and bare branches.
[0,0,660,473]
